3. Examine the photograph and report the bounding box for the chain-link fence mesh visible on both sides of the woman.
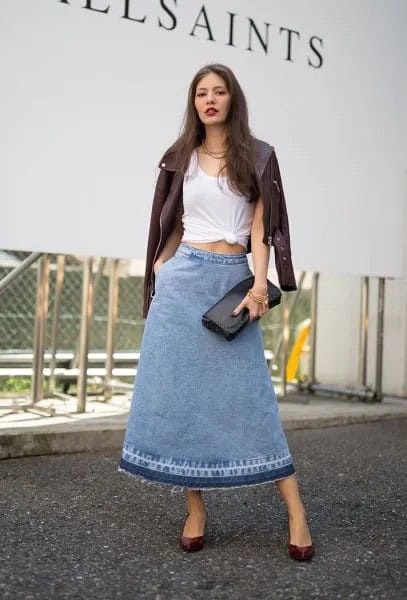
[0,252,311,376]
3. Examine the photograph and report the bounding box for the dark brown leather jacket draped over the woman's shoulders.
[143,138,297,318]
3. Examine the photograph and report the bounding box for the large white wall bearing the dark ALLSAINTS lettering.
[0,0,407,277]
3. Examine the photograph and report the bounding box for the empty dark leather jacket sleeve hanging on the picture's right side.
[271,148,297,292]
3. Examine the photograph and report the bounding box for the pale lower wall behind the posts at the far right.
[316,275,407,397]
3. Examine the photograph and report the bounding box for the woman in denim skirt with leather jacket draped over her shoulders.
[119,64,314,560]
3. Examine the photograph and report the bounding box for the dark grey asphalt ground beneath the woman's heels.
[0,418,407,600]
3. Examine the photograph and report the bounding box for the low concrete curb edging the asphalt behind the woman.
[0,413,407,460]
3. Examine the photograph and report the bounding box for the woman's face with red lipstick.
[195,73,231,125]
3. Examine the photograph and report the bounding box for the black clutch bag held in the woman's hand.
[202,275,281,341]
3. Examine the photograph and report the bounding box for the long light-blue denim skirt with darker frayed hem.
[119,242,295,489]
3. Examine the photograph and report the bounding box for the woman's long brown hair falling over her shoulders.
[168,63,260,202]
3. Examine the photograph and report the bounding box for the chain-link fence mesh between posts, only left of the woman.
[0,253,144,352]
